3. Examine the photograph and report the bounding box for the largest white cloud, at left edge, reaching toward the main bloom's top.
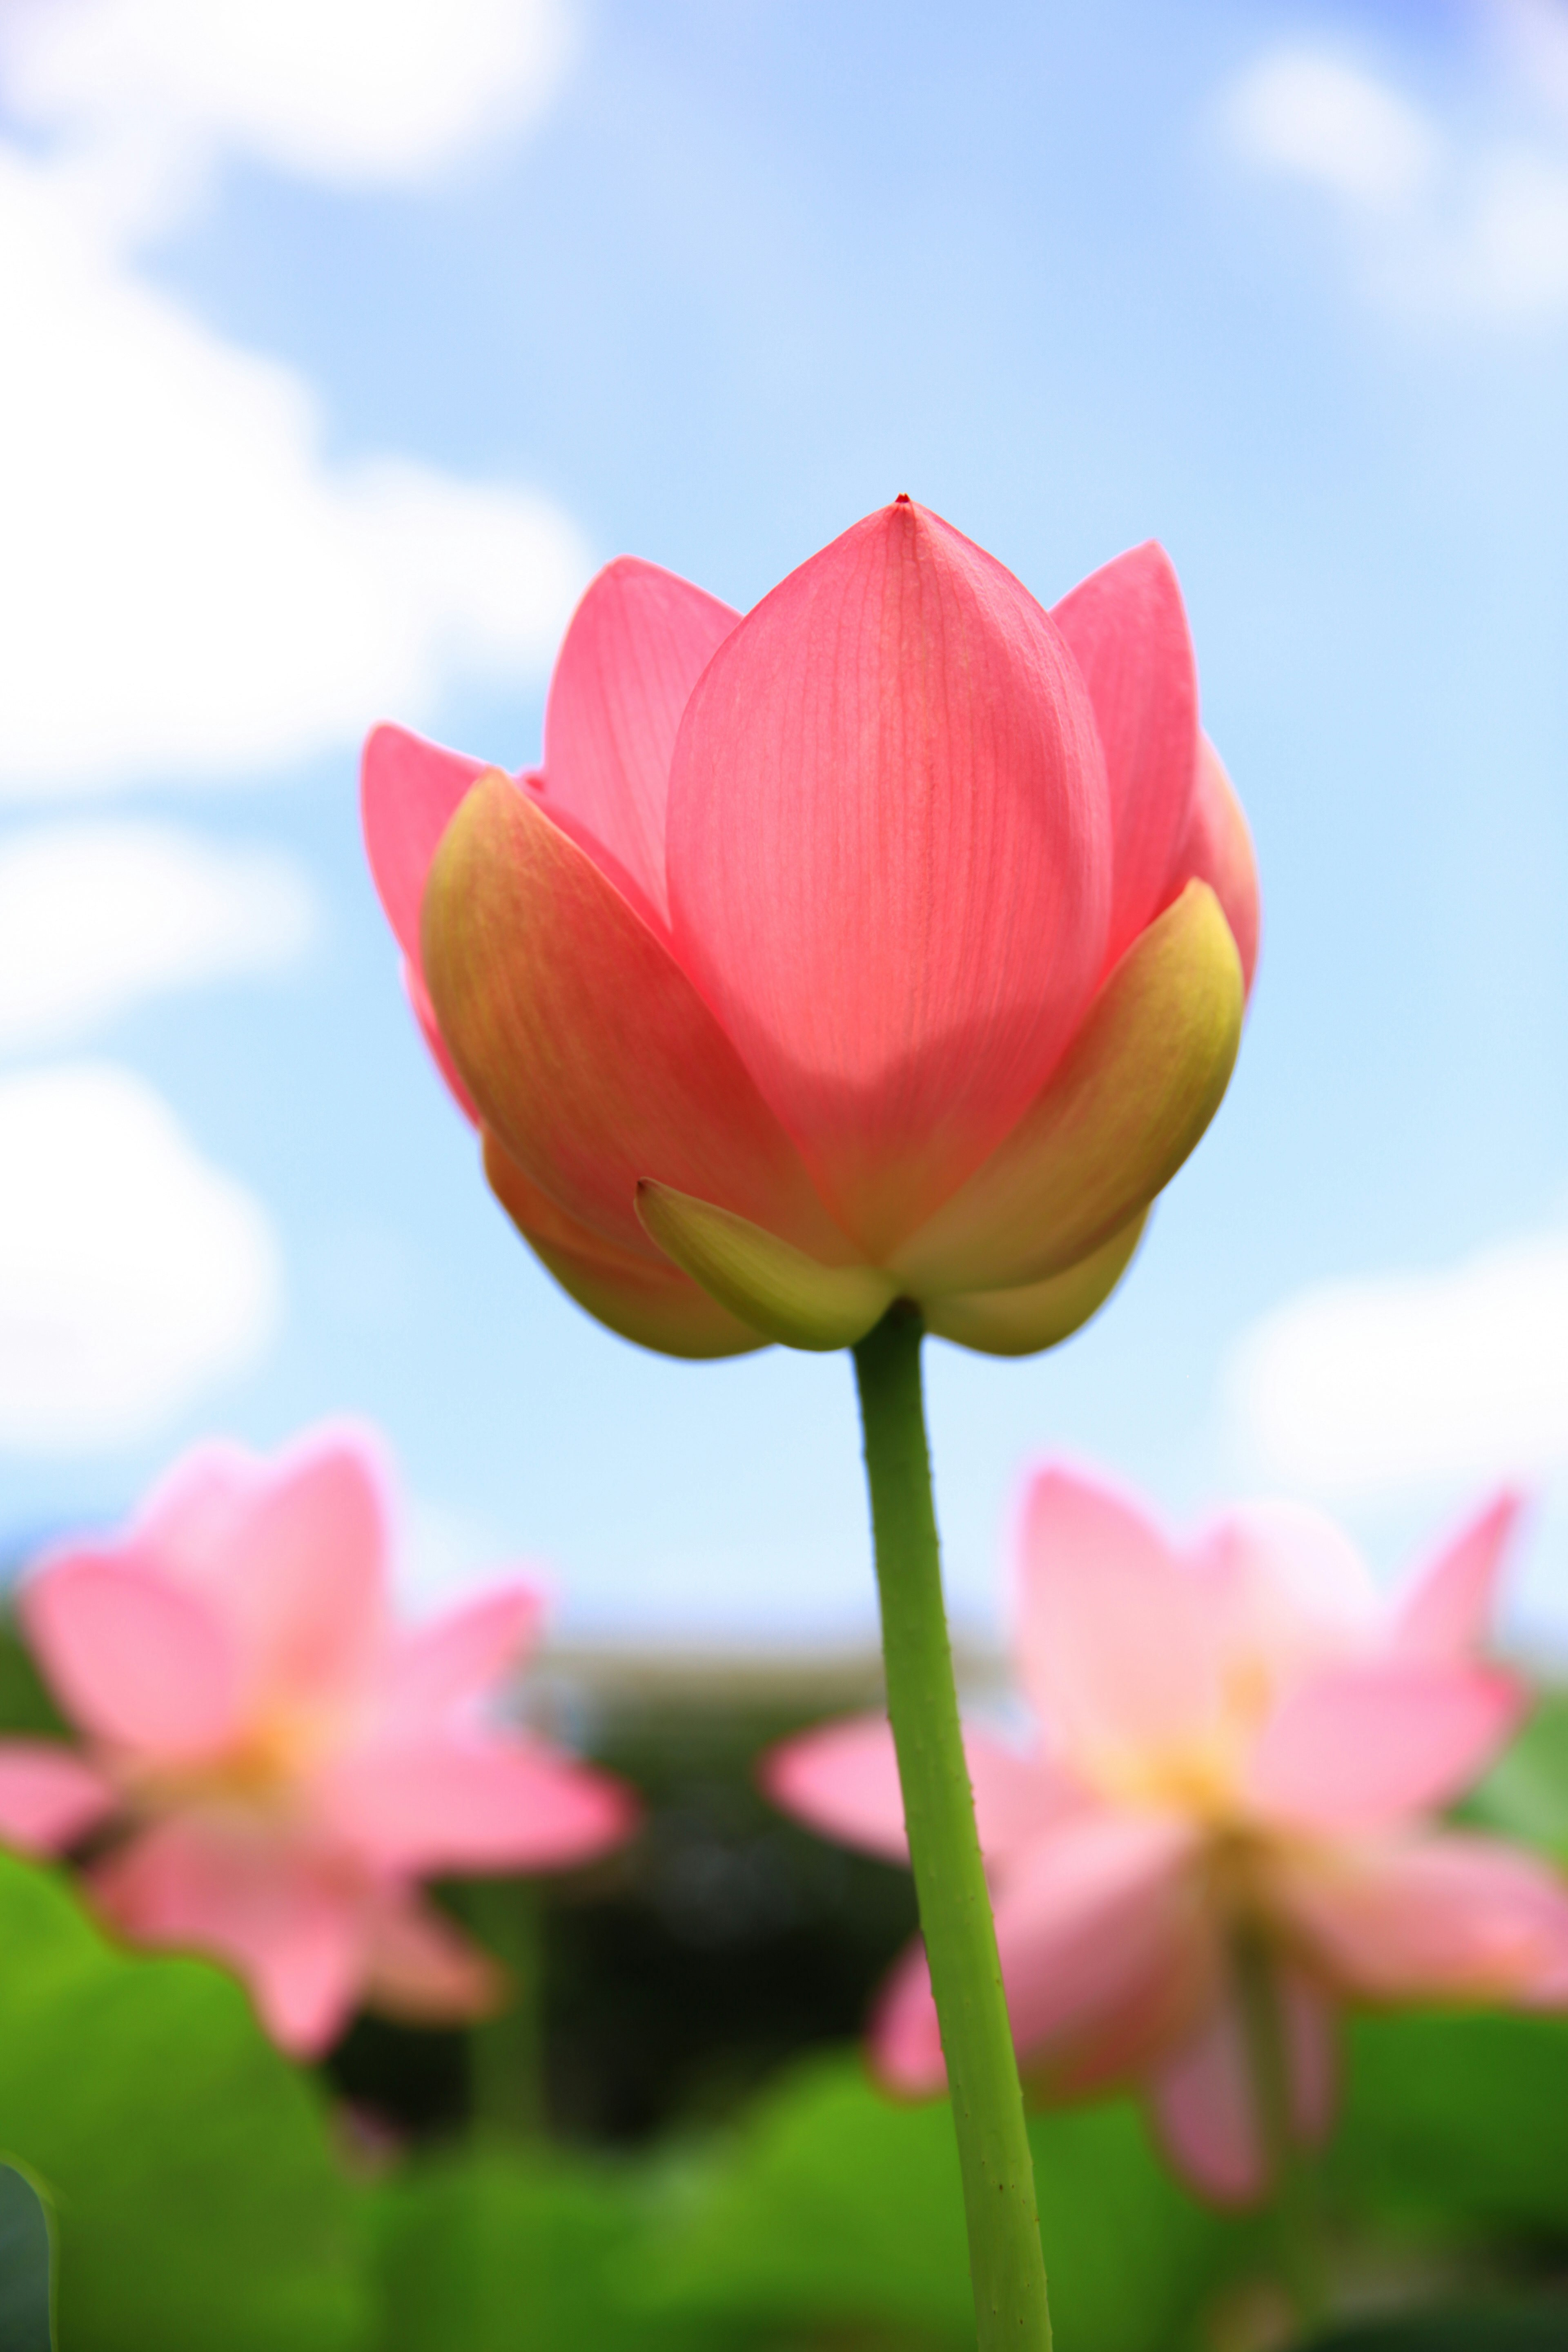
[0,151,588,797]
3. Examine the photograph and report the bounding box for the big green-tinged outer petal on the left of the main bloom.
[425,776,851,1261]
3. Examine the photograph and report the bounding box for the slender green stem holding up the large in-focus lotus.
[853,1301,1051,2352]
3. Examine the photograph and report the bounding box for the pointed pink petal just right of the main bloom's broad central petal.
[1051,539,1199,967]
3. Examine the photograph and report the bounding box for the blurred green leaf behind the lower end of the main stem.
[651,2053,1251,2352]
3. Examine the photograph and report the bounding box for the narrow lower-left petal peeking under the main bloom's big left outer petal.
[484,1134,766,1359]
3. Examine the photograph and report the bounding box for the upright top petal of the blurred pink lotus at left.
[212,1430,390,1712]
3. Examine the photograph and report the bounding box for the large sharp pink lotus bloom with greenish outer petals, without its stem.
[364,499,1258,1357]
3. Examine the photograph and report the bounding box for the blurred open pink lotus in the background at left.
[0,1432,635,2053]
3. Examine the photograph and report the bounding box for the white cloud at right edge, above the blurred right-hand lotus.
[1225,1235,1568,1498]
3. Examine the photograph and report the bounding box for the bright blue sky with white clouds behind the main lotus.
[0,0,1568,1637]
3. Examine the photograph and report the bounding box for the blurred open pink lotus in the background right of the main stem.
[762,1468,1568,2201]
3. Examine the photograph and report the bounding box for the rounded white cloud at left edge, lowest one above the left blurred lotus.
[0,1063,282,1454]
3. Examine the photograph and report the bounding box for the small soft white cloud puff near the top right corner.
[1229,49,1439,205]
